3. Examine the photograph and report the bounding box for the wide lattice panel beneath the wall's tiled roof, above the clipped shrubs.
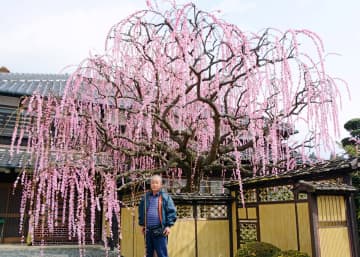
[259,185,294,202]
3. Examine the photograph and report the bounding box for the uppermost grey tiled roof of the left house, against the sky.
[0,73,69,96]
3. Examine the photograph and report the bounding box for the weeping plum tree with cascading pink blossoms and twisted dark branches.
[13,3,344,243]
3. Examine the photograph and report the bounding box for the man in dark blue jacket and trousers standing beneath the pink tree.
[139,175,176,257]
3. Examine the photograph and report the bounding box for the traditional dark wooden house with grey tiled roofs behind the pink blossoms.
[0,73,102,244]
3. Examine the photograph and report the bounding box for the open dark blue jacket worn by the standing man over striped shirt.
[139,191,176,227]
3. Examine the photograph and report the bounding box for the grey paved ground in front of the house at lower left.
[0,244,118,257]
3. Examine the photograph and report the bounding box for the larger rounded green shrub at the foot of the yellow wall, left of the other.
[236,242,280,257]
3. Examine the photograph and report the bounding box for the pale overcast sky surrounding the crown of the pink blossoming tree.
[0,0,360,152]
